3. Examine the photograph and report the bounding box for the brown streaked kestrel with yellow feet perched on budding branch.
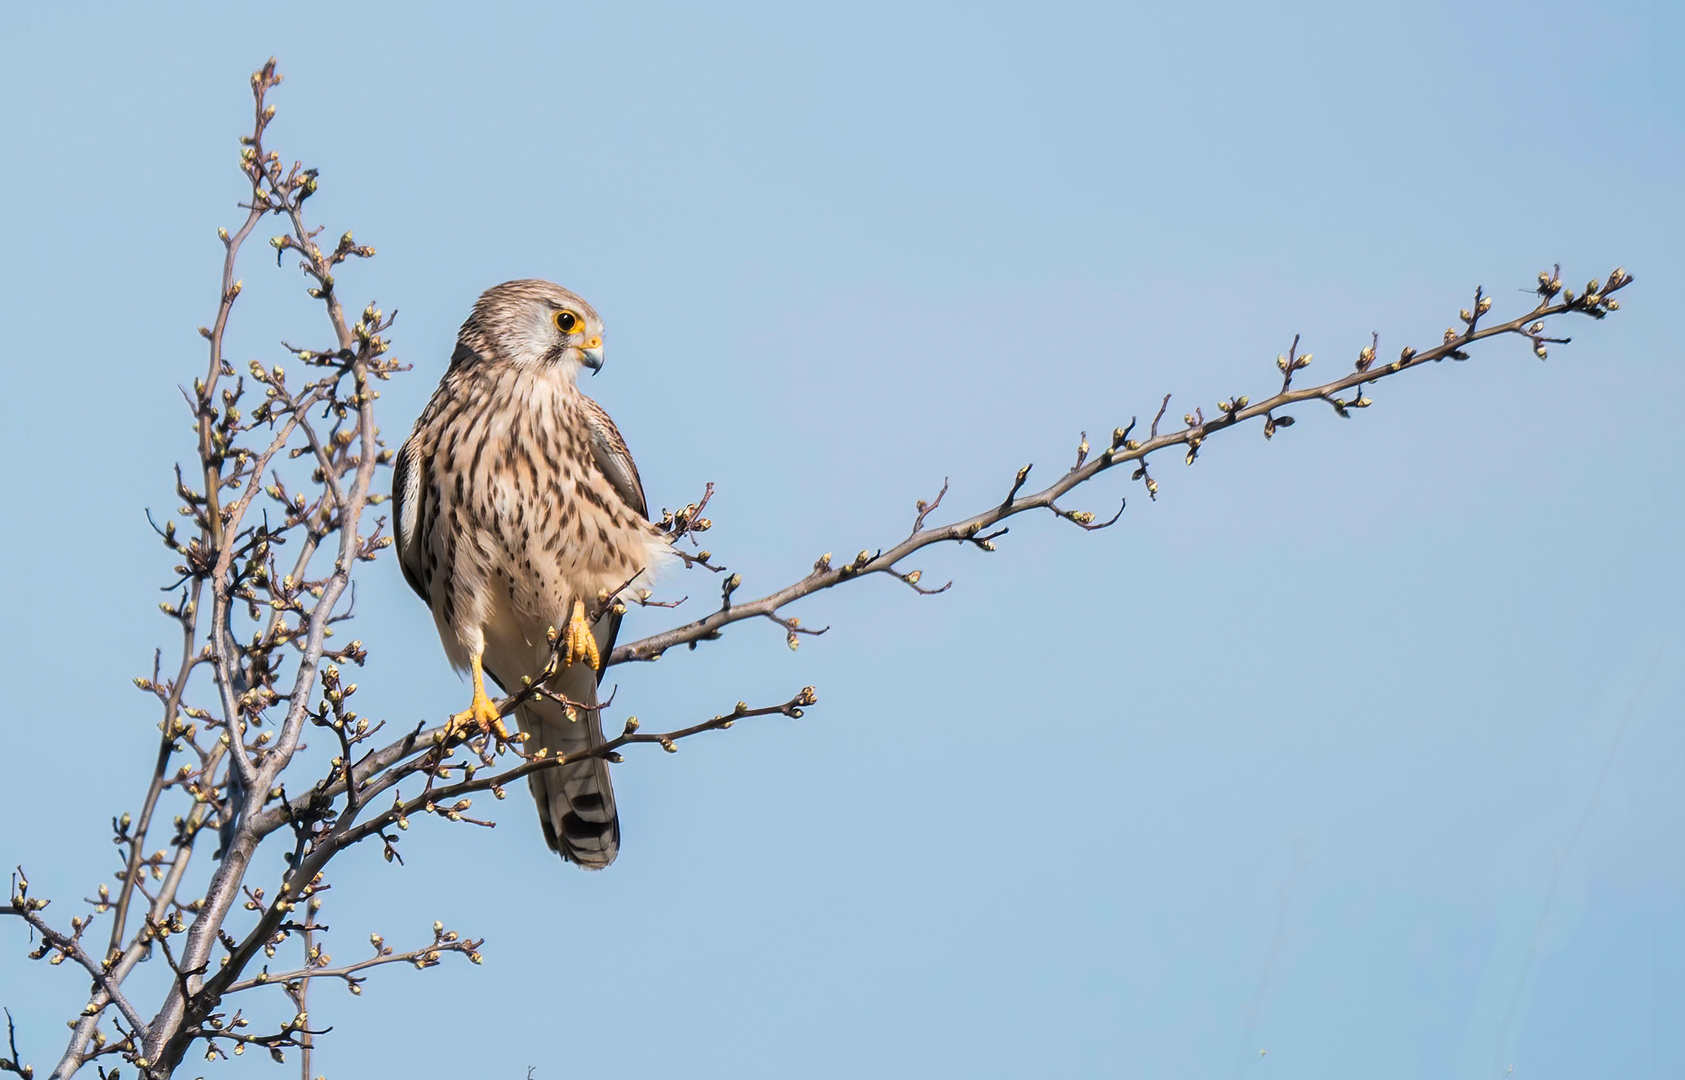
[393,281,671,869]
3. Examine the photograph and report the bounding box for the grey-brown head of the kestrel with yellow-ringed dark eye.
[453,280,603,379]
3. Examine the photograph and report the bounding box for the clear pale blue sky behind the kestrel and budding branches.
[0,0,1685,1080]
